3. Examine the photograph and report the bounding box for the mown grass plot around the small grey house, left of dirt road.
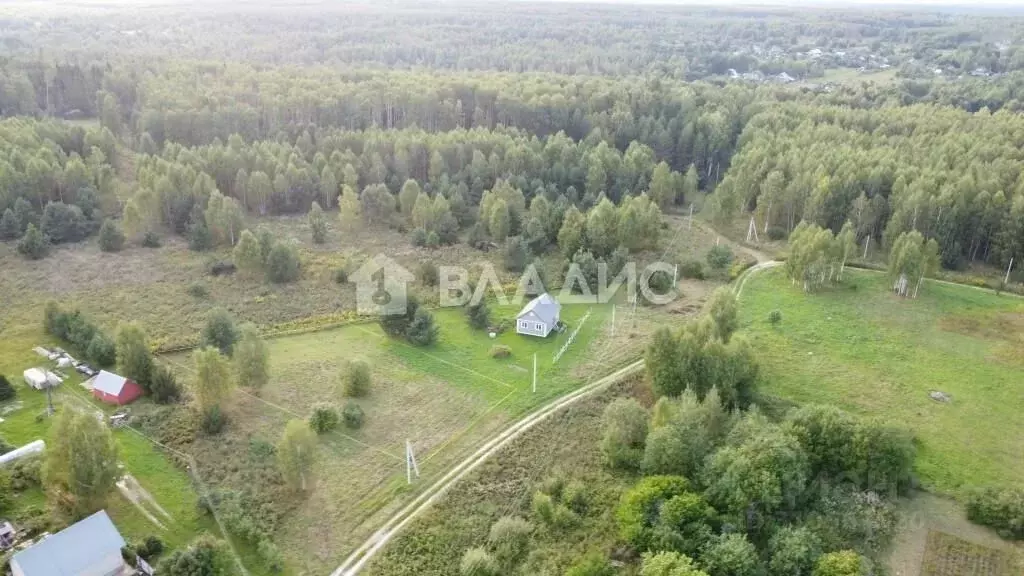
[162,304,610,573]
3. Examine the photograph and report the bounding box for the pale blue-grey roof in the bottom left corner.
[11,510,125,576]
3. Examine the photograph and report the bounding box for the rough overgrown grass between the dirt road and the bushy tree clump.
[367,382,643,576]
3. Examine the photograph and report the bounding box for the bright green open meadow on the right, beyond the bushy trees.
[739,268,1024,494]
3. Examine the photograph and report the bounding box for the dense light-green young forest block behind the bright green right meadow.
[715,104,1024,269]
